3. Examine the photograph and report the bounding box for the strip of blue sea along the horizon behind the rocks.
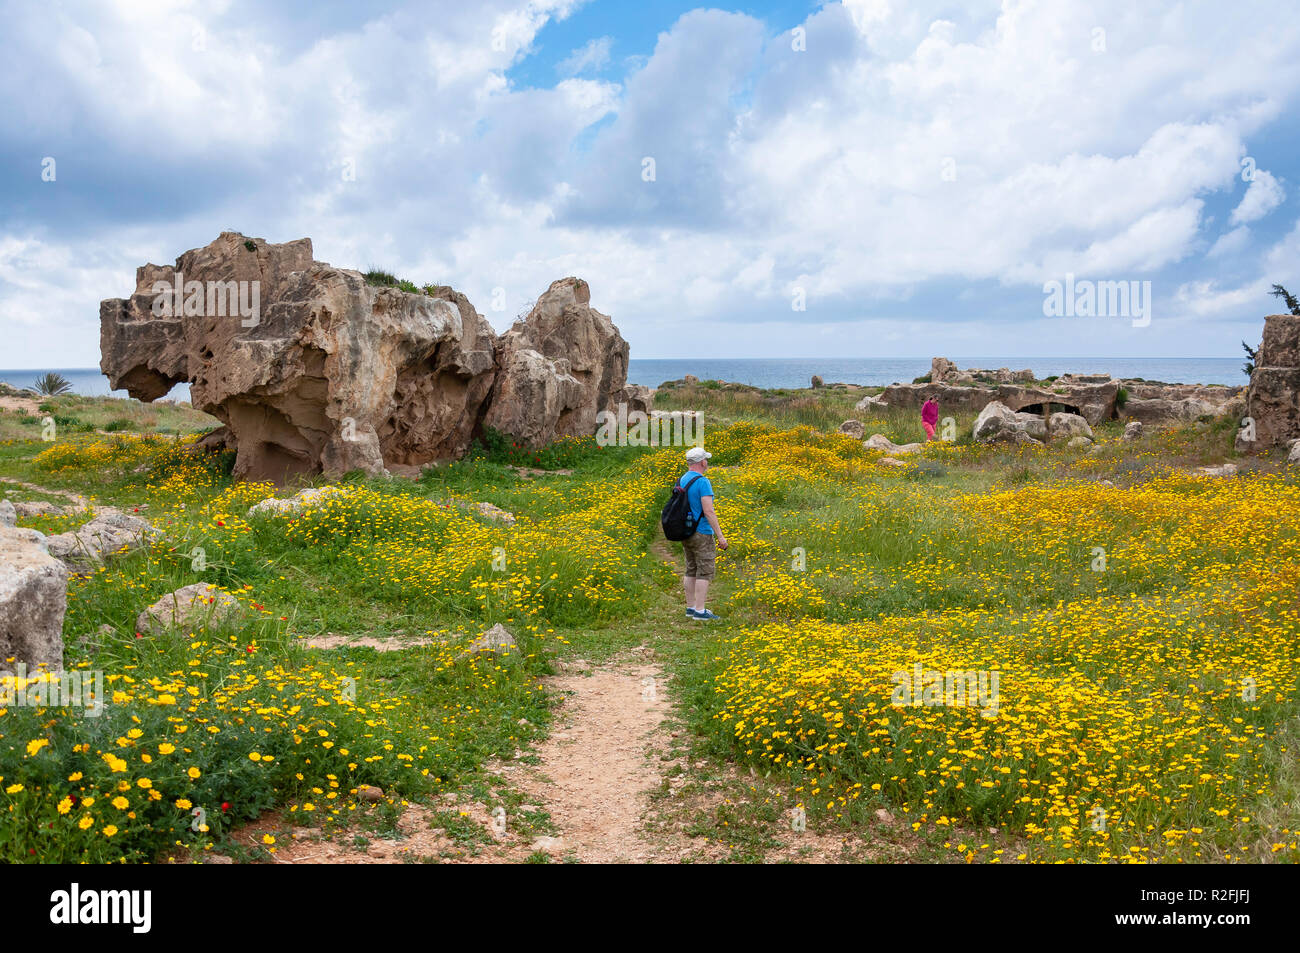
[0,355,1248,400]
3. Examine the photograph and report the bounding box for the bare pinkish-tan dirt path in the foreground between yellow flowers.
[506,649,676,863]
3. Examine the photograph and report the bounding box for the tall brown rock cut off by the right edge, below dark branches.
[1236,315,1300,452]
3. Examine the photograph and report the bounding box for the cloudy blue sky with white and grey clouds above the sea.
[0,0,1300,368]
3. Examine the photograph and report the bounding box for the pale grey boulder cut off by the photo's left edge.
[0,527,68,671]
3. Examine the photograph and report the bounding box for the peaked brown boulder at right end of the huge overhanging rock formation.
[484,278,628,446]
